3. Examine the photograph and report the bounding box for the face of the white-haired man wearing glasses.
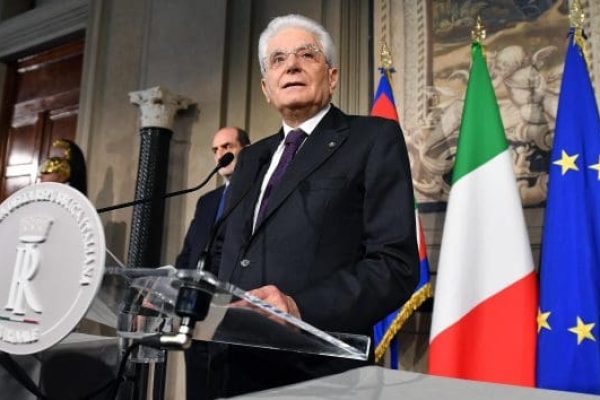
[262,28,337,119]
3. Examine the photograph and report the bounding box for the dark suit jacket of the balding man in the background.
[175,185,225,269]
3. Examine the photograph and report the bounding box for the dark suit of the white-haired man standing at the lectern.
[213,107,418,395]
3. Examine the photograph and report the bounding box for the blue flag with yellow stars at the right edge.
[537,29,600,394]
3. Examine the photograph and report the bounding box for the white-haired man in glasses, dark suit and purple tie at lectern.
[204,15,419,396]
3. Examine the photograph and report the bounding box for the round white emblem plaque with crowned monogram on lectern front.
[0,183,106,354]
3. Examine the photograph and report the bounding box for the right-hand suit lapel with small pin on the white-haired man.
[254,106,349,234]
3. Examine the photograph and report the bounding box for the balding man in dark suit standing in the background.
[175,127,250,269]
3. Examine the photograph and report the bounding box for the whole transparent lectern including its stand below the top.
[80,264,370,399]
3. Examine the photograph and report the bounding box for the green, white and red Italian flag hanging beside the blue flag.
[429,42,537,386]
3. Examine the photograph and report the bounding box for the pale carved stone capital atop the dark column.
[129,86,193,130]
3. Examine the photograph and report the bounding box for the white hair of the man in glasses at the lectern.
[258,14,337,76]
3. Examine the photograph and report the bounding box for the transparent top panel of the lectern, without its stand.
[101,267,370,360]
